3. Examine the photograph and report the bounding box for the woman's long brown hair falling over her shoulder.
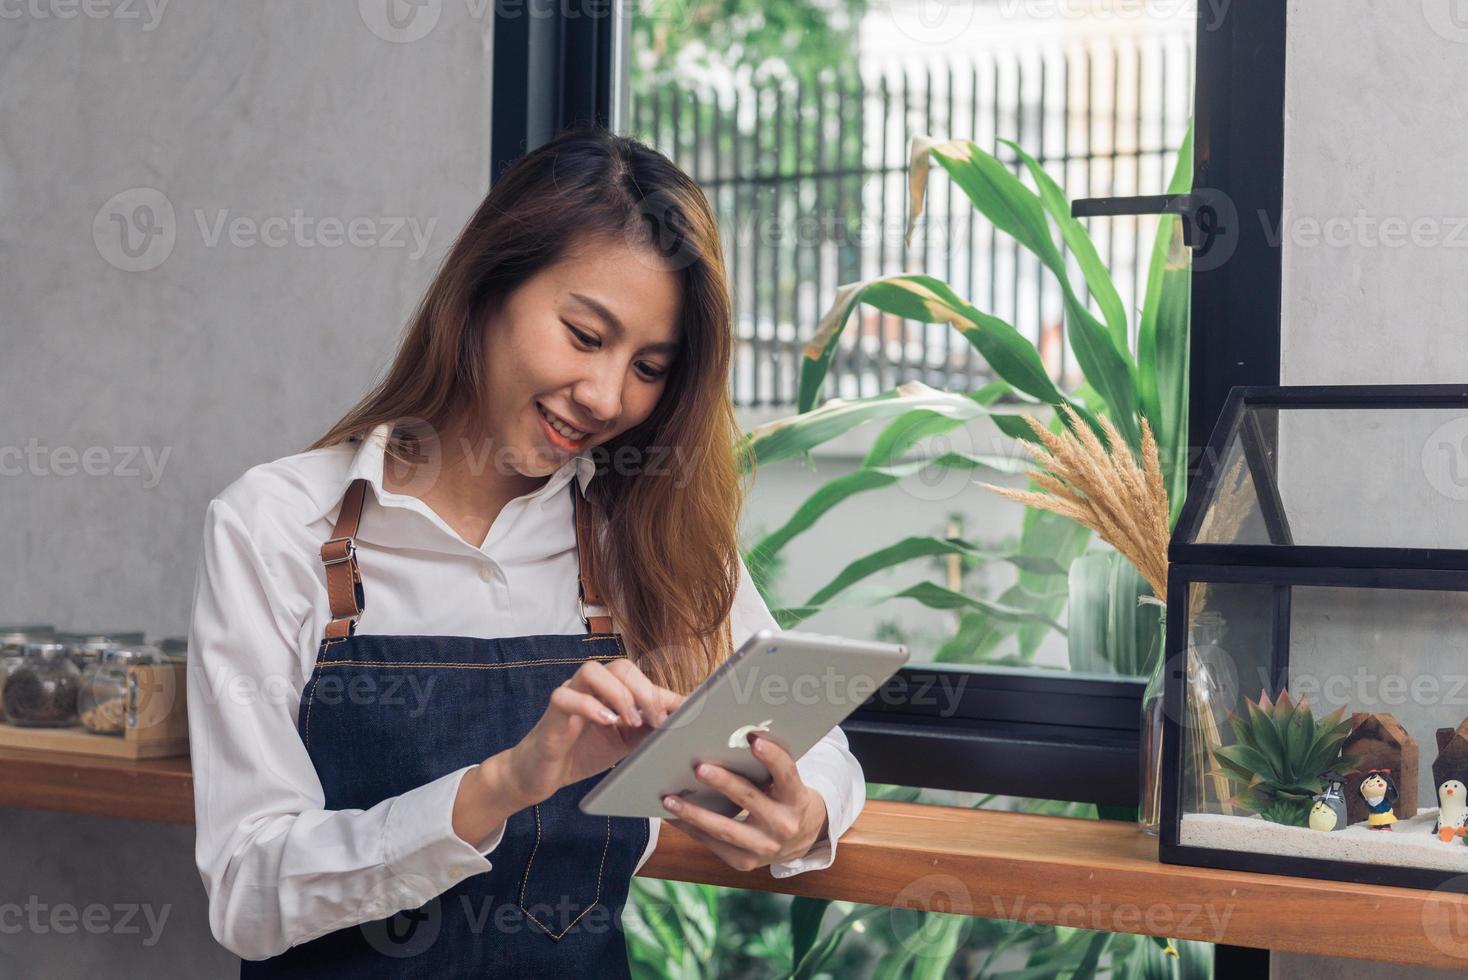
[311,126,747,692]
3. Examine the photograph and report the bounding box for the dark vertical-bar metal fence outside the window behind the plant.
[630,35,1193,406]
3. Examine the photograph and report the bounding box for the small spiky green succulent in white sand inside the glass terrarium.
[1213,690,1361,827]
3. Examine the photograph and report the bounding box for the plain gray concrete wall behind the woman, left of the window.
[0,0,492,977]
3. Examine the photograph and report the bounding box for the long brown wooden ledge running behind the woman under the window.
[0,748,1468,967]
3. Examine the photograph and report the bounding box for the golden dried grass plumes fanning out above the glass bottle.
[982,403,1171,600]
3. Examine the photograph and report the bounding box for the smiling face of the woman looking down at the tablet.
[483,242,683,477]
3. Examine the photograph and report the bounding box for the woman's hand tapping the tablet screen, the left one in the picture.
[501,657,684,805]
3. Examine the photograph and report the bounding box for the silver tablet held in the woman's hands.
[581,629,907,817]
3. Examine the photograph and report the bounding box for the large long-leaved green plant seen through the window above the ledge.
[740,122,1192,665]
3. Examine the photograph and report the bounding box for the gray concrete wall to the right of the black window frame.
[1273,0,1468,980]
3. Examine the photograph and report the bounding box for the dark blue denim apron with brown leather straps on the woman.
[241,478,649,977]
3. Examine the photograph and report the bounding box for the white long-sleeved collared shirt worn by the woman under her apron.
[186,425,866,959]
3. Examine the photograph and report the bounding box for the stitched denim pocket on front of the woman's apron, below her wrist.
[520,786,614,939]
